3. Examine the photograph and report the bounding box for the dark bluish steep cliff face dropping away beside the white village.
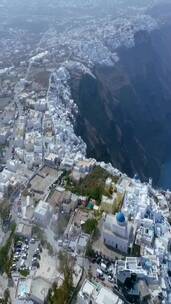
[71,26,171,182]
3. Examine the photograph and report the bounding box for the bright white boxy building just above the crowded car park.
[34,201,51,227]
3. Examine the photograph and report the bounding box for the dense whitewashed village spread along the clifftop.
[0,1,171,304]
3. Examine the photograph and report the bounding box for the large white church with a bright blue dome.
[103,212,133,253]
